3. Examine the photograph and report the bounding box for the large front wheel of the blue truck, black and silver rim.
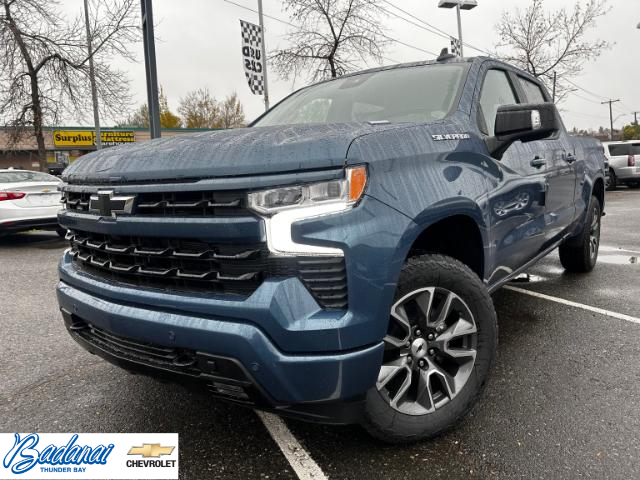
[363,255,498,443]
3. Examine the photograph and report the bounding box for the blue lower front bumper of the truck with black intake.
[57,256,383,423]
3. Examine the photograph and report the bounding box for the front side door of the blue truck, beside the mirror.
[477,67,546,278]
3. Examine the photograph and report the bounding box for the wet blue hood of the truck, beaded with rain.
[63,123,393,184]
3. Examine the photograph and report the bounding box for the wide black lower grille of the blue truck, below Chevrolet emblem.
[67,230,348,309]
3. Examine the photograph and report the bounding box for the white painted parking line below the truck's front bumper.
[255,410,327,480]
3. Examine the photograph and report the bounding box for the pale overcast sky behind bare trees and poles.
[63,0,640,128]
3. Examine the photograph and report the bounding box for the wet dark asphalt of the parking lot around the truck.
[0,190,640,479]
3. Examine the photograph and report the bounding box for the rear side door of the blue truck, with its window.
[517,75,584,246]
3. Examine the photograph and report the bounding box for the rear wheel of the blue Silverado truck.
[560,196,602,273]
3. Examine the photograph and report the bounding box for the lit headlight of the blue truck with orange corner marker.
[248,166,367,256]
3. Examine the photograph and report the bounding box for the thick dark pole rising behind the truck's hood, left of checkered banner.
[140,0,160,138]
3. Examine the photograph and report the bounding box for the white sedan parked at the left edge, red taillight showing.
[0,170,64,236]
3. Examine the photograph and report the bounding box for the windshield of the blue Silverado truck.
[254,64,466,127]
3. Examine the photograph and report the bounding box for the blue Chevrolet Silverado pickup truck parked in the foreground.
[57,54,605,442]
